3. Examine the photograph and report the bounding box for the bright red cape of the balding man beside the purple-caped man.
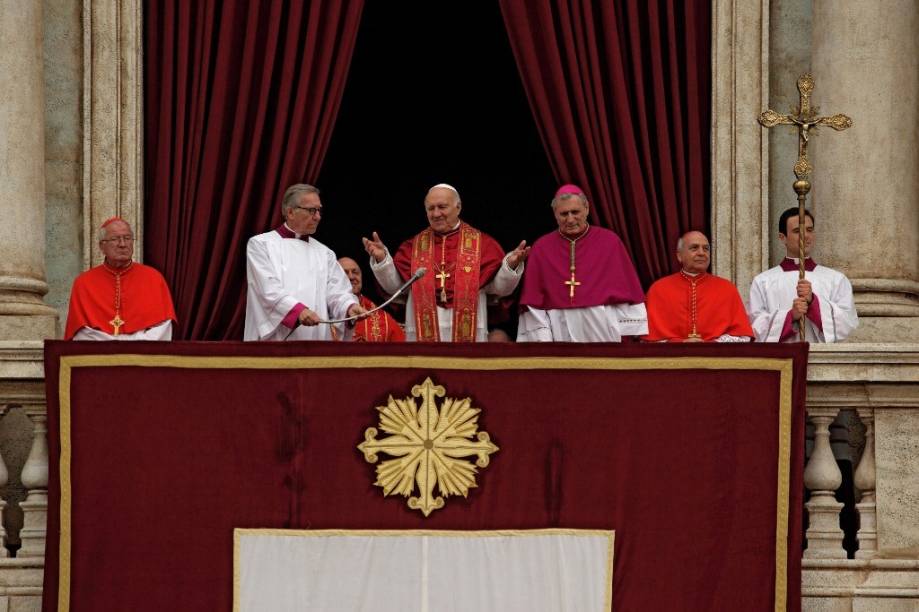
[643,272,753,342]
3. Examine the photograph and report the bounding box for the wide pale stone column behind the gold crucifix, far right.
[811,0,919,342]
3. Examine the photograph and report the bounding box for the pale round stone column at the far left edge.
[0,0,57,340]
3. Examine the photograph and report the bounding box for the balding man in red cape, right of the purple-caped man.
[643,231,753,342]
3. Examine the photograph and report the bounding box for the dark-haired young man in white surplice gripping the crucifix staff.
[750,207,858,342]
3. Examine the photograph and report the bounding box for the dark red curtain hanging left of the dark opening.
[144,0,364,340]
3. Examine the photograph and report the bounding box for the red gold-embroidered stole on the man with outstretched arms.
[412,223,482,342]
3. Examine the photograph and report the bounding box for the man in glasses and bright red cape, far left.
[64,217,176,340]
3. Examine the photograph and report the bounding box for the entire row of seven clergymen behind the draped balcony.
[65,183,858,342]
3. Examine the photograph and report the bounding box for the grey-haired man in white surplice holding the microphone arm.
[243,184,365,340]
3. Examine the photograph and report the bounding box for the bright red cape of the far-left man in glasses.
[64,262,176,340]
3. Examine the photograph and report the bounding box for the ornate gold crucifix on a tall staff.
[759,74,852,342]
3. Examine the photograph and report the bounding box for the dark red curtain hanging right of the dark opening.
[500,0,711,287]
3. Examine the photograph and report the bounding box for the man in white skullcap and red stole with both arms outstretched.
[363,183,529,342]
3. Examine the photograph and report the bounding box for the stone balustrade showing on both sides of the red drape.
[0,342,919,611]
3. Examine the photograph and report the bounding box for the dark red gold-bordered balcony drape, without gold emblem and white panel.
[43,342,807,612]
